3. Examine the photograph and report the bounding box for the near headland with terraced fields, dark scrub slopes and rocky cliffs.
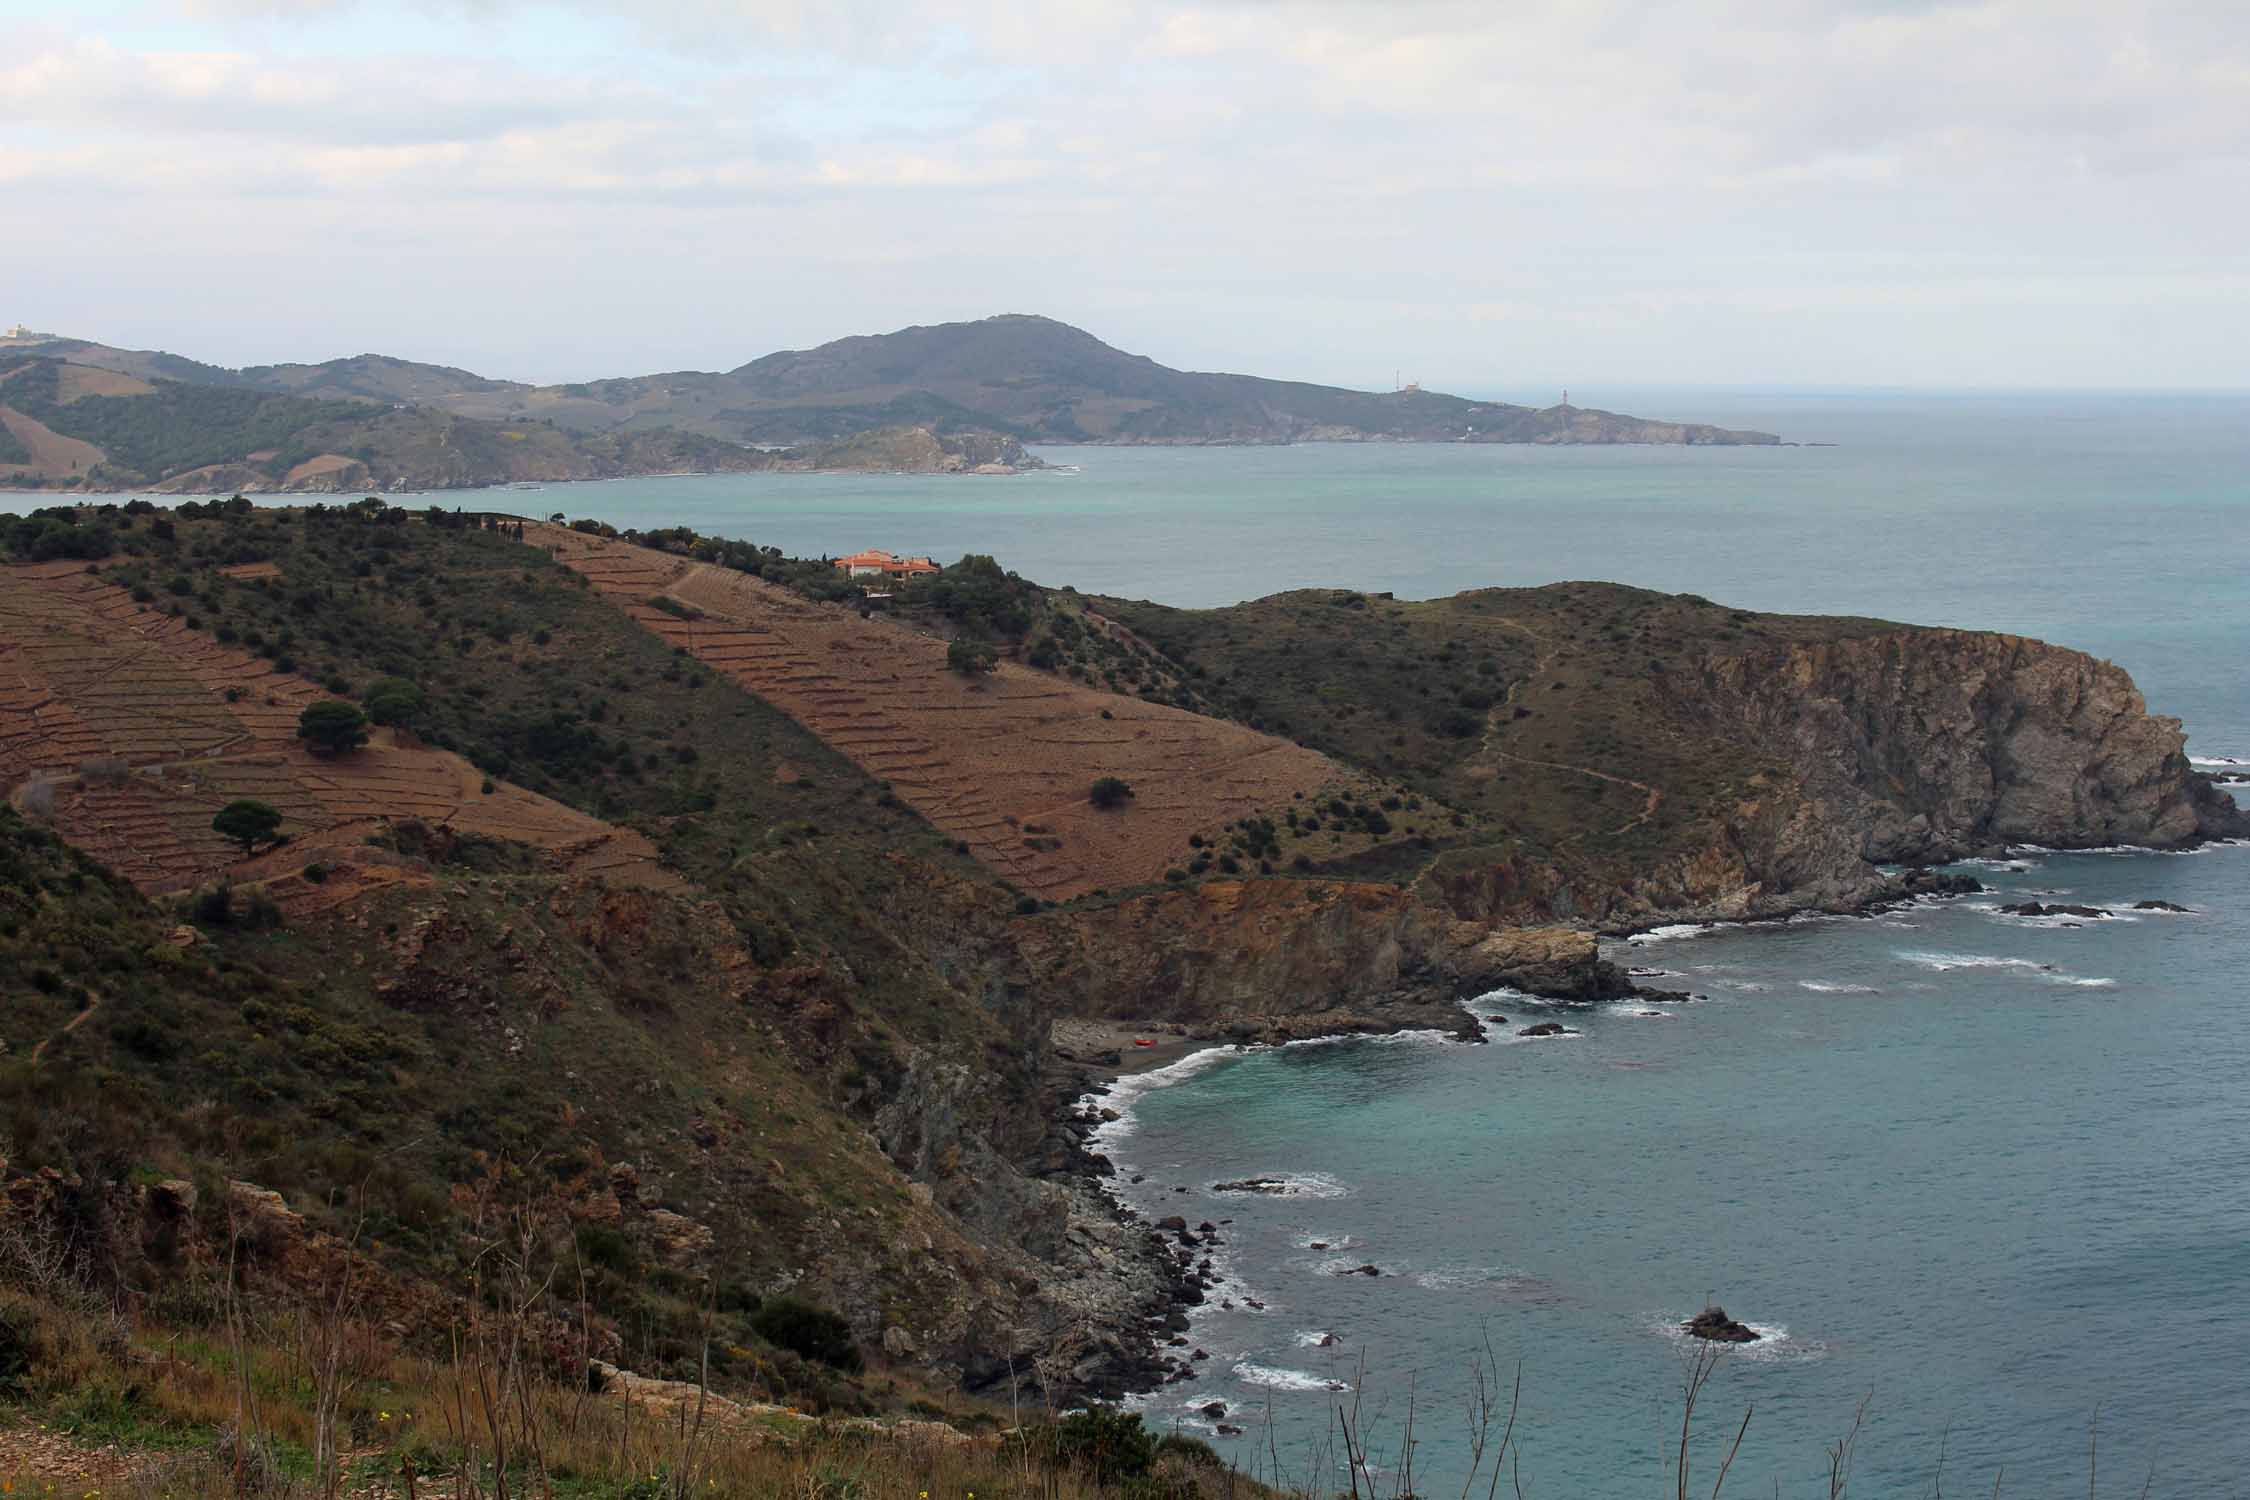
[0,499,2250,1412]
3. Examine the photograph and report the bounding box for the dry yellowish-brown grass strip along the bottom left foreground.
[0,1286,1265,1500]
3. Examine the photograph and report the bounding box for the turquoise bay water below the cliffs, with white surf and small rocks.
[1107,848,2250,1496]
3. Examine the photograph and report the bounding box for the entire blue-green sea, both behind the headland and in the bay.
[25,389,2250,1498]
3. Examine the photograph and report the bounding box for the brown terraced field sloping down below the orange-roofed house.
[531,526,1361,900]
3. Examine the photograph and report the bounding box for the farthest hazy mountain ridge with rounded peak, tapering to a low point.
[0,315,1780,445]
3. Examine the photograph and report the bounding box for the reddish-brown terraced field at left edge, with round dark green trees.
[0,562,682,911]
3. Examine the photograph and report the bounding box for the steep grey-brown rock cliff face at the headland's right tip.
[1665,630,2250,868]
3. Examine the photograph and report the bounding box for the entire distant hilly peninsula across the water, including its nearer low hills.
[0,315,1780,495]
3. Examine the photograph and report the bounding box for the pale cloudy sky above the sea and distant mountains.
[0,0,2250,394]
